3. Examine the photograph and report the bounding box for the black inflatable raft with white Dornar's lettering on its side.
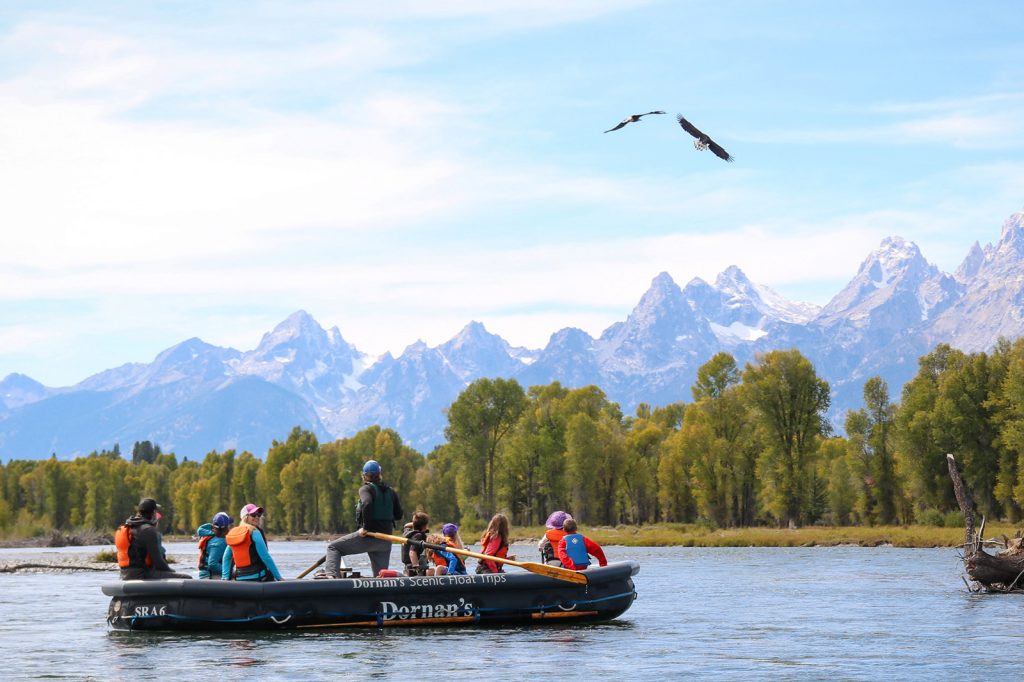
[102,561,640,630]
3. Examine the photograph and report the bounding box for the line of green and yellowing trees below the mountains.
[6,341,1024,536]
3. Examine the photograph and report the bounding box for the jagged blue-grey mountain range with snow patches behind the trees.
[0,213,1024,459]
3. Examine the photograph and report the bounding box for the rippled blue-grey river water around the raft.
[0,542,1024,680]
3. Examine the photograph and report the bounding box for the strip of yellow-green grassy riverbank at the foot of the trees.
[0,523,1017,548]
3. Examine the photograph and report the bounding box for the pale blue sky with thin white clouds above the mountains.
[0,0,1024,386]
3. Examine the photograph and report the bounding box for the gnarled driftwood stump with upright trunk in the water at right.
[946,455,1024,592]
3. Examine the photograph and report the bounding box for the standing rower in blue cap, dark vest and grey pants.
[324,460,402,578]
